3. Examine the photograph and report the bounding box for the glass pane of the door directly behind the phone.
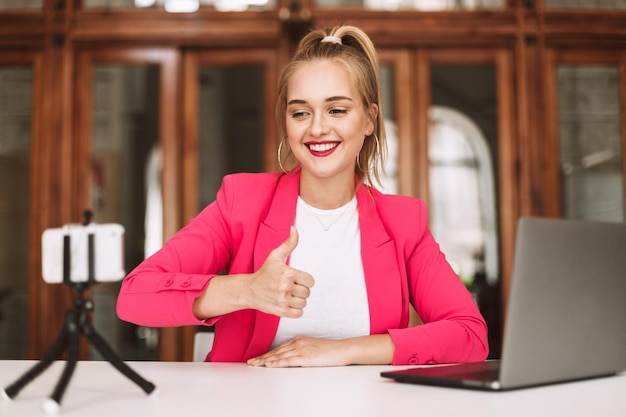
[90,64,163,359]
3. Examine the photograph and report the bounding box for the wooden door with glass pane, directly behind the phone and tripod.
[72,47,182,359]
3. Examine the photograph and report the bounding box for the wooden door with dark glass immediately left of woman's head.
[182,49,280,214]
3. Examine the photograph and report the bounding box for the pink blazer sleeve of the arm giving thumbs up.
[116,177,231,327]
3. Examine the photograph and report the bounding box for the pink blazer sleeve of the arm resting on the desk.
[389,201,489,364]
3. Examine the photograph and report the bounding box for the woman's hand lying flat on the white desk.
[248,336,349,368]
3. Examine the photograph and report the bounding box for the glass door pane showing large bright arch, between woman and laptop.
[428,64,500,356]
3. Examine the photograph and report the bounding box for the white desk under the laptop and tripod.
[0,361,626,417]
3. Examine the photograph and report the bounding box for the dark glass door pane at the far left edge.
[0,66,33,359]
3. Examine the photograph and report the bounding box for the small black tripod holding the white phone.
[4,212,156,413]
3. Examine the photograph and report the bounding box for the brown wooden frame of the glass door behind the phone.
[72,47,182,358]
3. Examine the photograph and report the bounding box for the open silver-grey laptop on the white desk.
[381,217,626,391]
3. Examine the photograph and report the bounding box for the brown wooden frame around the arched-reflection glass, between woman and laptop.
[400,47,516,344]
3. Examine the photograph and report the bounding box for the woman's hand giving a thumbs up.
[250,226,315,318]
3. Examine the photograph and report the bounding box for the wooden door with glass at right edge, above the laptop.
[544,48,626,222]
